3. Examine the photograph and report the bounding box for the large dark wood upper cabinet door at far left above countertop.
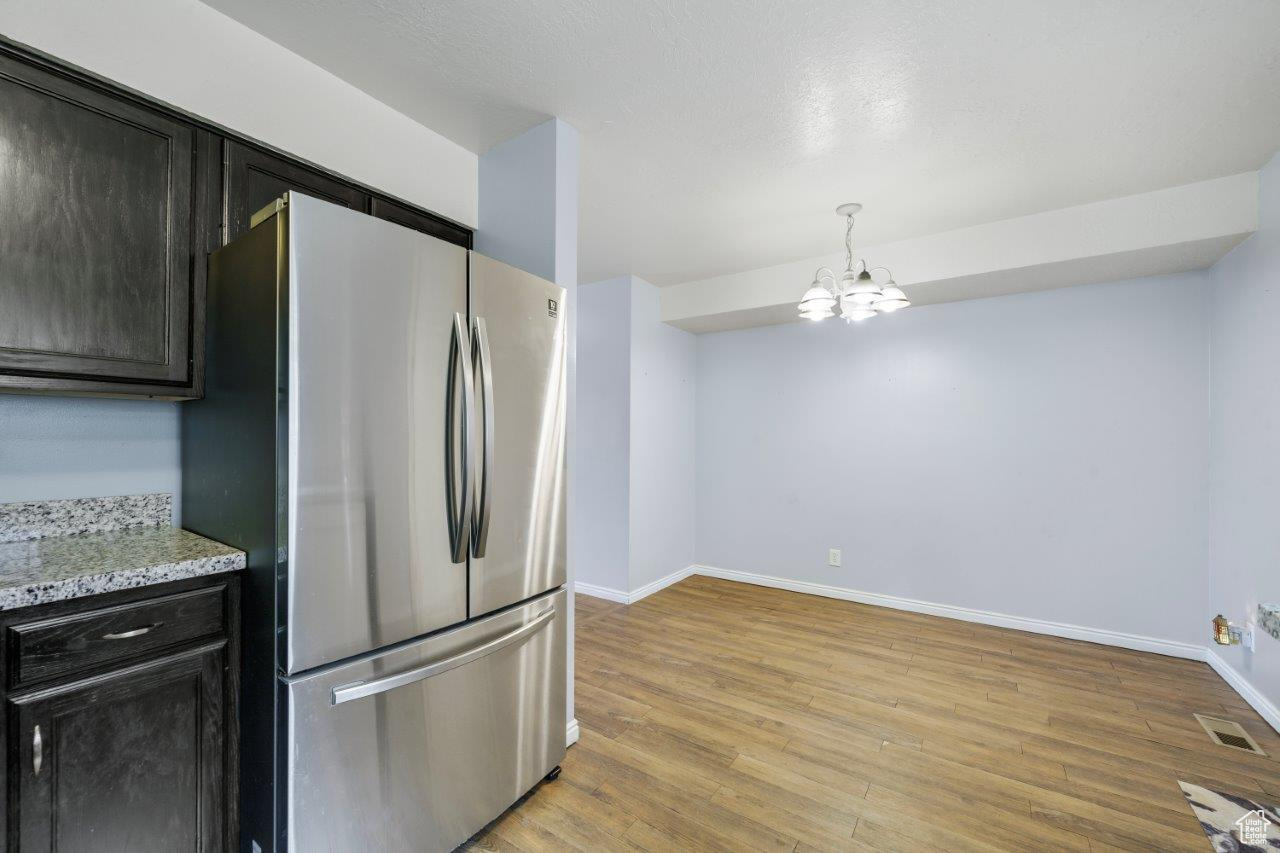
[0,54,202,396]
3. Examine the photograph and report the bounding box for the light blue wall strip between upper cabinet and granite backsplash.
[0,394,180,517]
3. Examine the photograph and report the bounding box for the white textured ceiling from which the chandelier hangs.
[199,0,1280,284]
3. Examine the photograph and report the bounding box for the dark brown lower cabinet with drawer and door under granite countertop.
[4,578,238,853]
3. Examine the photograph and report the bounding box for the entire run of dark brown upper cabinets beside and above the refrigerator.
[0,36,471,400]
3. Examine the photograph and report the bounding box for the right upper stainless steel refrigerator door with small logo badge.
[470,252,567,616]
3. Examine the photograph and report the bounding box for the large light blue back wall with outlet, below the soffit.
[696,273,1210,646]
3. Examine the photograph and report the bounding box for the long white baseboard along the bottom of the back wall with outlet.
[690,566,1206,661]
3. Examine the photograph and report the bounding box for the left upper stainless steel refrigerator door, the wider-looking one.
[282,193,475,674]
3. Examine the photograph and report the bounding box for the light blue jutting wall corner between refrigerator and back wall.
[575,275,698,594]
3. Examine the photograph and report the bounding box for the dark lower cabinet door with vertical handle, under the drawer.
[8,642,227,853]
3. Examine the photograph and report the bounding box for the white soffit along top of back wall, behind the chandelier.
[662,172,1258,333]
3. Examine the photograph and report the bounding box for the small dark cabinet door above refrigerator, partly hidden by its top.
[224,140,369,242]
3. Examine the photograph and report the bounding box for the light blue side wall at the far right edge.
[1210,156,1280,706]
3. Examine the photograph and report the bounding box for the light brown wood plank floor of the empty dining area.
[470,576,1280,850]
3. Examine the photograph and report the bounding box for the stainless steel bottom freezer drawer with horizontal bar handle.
[285,589,566,850]
